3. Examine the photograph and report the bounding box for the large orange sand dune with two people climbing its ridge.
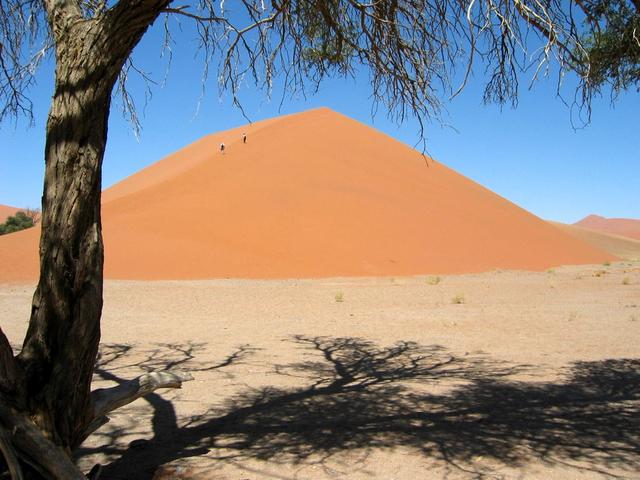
[0,108,615,281]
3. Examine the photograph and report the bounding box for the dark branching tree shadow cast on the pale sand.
[79,336,640,479]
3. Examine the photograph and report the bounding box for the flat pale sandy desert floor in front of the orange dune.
[0,262,640,480]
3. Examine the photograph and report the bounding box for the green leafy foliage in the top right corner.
[582,0,640,92]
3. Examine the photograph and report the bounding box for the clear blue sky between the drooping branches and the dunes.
[0,15,640,223]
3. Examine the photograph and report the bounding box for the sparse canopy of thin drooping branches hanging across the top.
[0,0,640,132]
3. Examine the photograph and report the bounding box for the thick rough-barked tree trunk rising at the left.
[0,0,170,453]
